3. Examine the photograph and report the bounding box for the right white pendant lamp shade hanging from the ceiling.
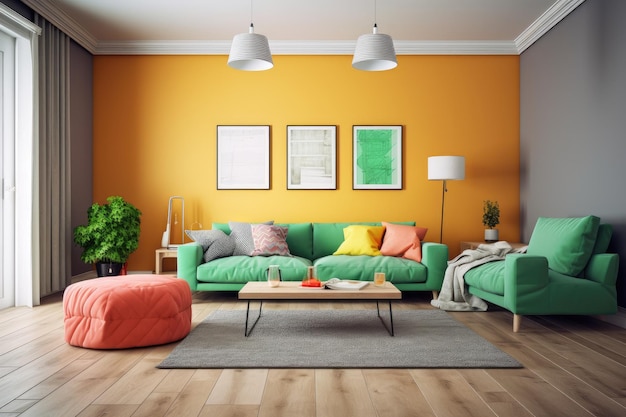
[352,27,398,71]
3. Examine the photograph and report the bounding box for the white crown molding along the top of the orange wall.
[93,40,518,55]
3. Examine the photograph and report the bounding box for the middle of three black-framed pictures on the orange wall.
[287,126,337,190]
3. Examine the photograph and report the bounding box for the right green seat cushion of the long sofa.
[314,255,428,284]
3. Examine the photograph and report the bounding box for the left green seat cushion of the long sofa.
[197,255,312,284]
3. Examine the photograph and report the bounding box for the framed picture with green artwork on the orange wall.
[352,126,402,190]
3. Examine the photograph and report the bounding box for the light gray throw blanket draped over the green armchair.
[430,241,526,311]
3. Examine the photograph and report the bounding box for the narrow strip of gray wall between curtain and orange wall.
[70,42,93,276]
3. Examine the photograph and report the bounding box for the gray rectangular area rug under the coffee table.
[158,306,522,369]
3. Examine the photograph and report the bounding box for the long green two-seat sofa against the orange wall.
[177,222,448,297]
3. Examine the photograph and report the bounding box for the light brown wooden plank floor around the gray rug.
[0,293,626,417]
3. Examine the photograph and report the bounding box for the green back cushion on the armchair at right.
[527,216,600,276]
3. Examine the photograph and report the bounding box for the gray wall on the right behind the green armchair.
[520,0,626,307]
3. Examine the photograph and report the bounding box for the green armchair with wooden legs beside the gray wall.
[464,216,619,332]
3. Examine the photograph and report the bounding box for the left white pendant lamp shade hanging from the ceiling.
[228,32,274,71]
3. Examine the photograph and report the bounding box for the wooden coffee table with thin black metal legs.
[239,281,402,337]
